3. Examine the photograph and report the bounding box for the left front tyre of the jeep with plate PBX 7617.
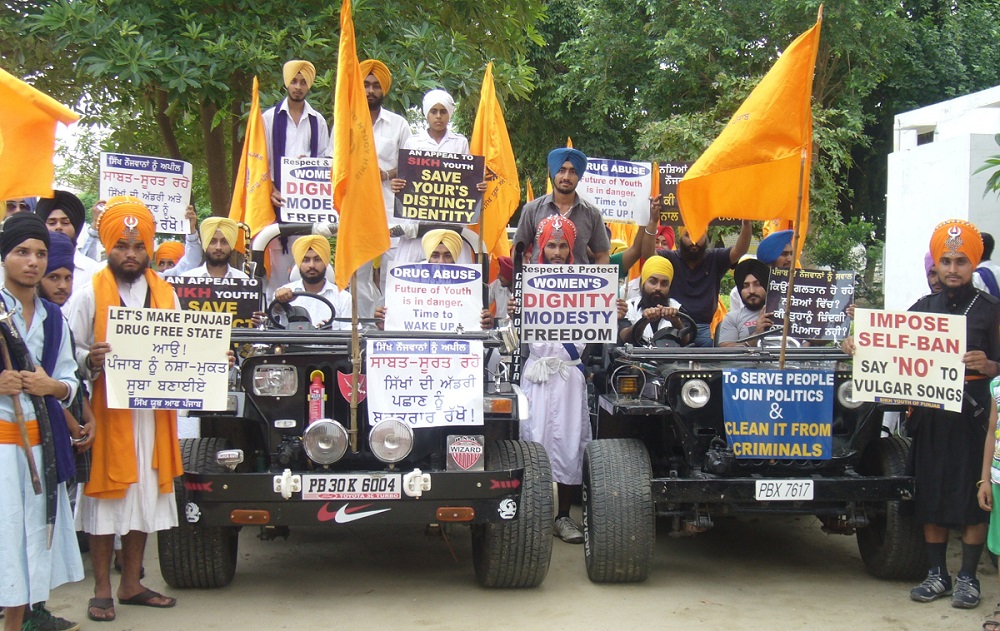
[583,439,656,583]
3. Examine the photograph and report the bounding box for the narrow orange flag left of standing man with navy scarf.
[229,77,275,236]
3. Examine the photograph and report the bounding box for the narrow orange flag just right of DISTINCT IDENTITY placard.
[468,62,521,257]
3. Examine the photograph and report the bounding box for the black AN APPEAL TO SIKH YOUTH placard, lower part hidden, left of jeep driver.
[166,276,261,328]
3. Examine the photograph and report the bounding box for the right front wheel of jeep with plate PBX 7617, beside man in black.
[858,436,927,580]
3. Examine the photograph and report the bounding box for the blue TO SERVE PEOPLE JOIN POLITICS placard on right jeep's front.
[722,369,833,460]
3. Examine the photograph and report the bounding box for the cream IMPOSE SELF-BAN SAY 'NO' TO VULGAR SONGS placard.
[851,309,966,412]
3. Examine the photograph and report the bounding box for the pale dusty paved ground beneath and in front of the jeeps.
[50,517,998,631]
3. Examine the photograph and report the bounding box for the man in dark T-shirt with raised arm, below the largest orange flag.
[657,220,750,346]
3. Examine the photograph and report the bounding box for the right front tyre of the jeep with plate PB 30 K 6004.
[472,440,553,587]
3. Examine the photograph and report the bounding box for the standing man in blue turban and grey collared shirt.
[514,147,611,263]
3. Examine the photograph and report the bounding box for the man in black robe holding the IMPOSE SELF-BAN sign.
[843,219,1000,608]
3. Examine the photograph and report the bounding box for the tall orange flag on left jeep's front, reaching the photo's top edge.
[330,0,390,289]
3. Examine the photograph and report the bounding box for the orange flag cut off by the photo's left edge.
[0,69,80,199]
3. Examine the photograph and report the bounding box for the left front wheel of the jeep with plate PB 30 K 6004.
[157,438,239,587]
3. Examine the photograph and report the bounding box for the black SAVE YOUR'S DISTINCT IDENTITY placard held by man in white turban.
[393,149,485,225]
